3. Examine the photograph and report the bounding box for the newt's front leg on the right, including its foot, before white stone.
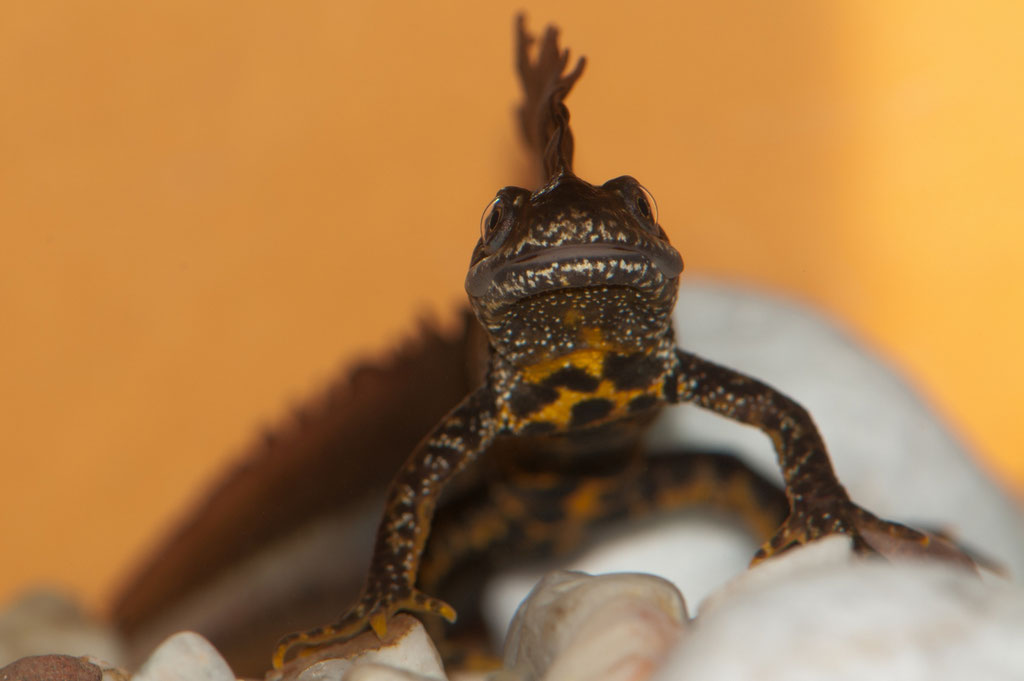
[666,350,974,568]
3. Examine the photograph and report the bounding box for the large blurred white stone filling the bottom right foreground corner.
[654,542,1024,681]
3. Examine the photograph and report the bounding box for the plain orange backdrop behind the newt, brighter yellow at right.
[0,0,1024,606]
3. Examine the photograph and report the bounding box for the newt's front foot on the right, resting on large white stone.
[752,501,977,571]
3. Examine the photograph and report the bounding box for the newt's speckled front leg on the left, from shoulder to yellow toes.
[273,387,498,668]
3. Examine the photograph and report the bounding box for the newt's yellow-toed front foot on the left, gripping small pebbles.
[273,589,456,669]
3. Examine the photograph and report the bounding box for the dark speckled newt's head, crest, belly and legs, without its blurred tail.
[272,17,972,668]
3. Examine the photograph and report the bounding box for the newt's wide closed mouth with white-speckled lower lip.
[466,243,683,300]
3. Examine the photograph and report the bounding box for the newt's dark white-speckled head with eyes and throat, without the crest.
[466,172,683,365]
